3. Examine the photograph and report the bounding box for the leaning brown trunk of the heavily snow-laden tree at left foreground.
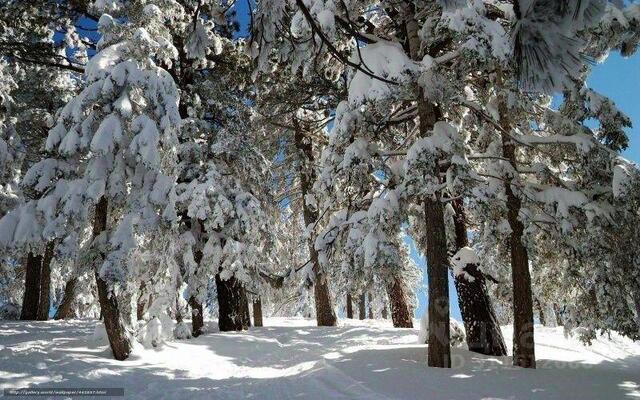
[93,197,131,360]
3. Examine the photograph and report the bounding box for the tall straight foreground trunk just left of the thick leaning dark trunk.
[400,3,451,368]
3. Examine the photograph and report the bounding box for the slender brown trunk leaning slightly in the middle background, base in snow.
[294,126,336,326]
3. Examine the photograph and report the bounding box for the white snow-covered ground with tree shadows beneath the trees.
[0,318,640,400]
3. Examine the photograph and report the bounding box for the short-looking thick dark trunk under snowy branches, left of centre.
[216,274,251,332]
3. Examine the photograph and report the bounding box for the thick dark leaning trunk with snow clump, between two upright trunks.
[452,199,507,356]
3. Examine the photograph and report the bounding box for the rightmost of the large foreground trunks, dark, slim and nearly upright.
[501,136,536,368]
